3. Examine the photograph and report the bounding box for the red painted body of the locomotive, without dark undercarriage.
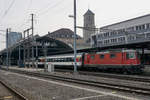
[84,52,140,65]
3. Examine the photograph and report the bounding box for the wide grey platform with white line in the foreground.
[0,67,149,100]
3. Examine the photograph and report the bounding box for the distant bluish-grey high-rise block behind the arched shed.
[6,32,22,47]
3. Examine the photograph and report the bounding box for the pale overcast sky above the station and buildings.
[0,0,150,50]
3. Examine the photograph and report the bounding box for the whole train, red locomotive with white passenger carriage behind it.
[28,50,144,73]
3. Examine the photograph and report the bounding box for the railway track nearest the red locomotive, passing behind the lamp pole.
[56,69,150,83]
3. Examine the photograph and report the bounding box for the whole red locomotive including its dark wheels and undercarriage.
[84,50,143,73]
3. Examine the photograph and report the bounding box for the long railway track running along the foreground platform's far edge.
[1,69,150,95]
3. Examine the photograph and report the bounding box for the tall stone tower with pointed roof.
[83,9,95,44]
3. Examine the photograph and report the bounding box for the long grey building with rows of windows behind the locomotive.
[91,14,150,47]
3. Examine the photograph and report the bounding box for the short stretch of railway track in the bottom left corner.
[0,79,29,100]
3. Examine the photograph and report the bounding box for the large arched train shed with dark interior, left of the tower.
[0,36,73,64]
